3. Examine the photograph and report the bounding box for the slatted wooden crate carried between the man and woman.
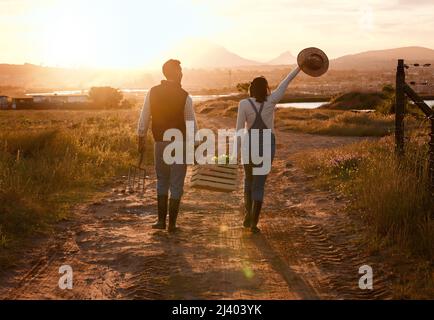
[191,164,238,192]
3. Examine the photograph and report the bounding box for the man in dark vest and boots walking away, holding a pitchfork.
[137,60,197,232]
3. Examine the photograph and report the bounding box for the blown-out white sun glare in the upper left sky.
[39,1,219,68]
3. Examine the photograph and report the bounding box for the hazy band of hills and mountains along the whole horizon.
[0,42,434,90]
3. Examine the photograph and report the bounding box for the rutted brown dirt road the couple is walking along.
[0,115,390,299]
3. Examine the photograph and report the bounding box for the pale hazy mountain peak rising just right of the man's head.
[167,40,262,69]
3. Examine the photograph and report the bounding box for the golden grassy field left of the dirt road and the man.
[0,110,152,264]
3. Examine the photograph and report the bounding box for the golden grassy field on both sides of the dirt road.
[0,100,434,297]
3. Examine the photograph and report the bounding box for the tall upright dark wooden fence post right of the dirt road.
[395,59,405,155]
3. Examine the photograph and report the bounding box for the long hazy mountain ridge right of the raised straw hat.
[330,47,434,70]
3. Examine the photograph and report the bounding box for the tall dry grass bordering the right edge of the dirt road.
[299,131,434,298]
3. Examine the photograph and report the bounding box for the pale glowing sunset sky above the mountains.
[0,0,434,68]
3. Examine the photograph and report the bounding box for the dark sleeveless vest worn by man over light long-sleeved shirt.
[150,81,188,141]
